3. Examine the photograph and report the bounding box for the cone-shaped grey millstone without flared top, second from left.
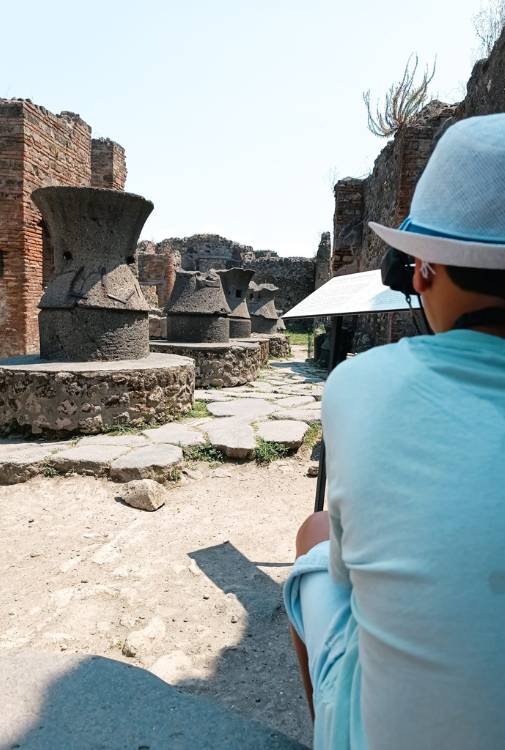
[165,270,230,344]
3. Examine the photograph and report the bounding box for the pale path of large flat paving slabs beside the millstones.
[0,347,325,485]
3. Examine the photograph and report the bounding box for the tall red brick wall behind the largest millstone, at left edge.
[0,99,124,358]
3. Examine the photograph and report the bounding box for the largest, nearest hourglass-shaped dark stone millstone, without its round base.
[32,187,154,362]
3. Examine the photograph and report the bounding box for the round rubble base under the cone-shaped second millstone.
[151,340,262,388]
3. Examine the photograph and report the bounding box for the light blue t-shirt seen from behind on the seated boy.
[323,331,505,750]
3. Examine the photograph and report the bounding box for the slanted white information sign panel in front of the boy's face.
[282,271,419,319]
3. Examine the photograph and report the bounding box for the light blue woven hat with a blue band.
[369,114,505,269]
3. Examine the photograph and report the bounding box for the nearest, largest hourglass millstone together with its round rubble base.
[0,187,194,436]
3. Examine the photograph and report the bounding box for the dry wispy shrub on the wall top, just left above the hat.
[363,55,438,138]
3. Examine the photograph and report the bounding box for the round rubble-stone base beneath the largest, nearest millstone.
[0,354,195,437]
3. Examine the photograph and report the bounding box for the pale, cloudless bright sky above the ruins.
[0,0,486,255]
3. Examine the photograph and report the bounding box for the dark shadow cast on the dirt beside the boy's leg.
[178,542,311,744]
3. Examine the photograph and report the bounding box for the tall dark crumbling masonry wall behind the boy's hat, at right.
[332,26,505,350]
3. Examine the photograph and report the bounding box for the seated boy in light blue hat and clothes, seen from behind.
[285,114,505,750]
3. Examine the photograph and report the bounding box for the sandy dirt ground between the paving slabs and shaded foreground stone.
[0,449,316,744]
